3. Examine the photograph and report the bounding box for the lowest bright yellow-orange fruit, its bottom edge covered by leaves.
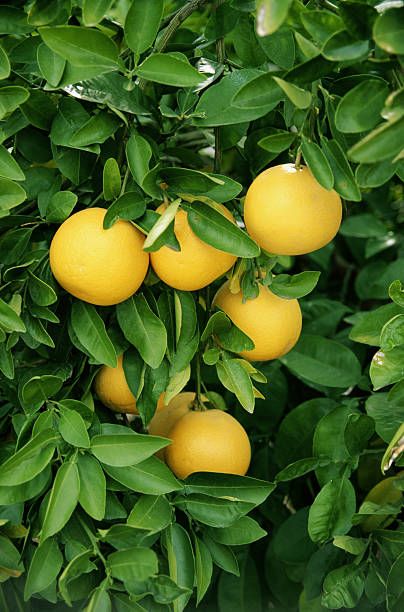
[165,409,251,479]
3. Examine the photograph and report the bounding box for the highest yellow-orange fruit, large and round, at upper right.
[244,164,342,255]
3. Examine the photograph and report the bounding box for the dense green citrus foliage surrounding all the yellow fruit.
[0,0,404,612]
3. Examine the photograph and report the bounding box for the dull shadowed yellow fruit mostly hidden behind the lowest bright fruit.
[148,391,195,459]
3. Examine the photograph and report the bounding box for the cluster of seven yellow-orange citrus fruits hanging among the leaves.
[50,164,342,478]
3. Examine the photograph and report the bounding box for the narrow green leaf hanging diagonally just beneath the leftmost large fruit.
[71,301,118,368]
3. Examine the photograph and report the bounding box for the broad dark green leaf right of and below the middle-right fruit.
[281,334,361,388]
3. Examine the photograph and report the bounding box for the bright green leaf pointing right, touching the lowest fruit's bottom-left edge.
[104,457,182,495]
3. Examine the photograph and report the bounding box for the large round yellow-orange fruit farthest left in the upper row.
[50,208,149,306]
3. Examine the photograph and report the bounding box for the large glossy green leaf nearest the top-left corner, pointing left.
[38,26,118,74]
